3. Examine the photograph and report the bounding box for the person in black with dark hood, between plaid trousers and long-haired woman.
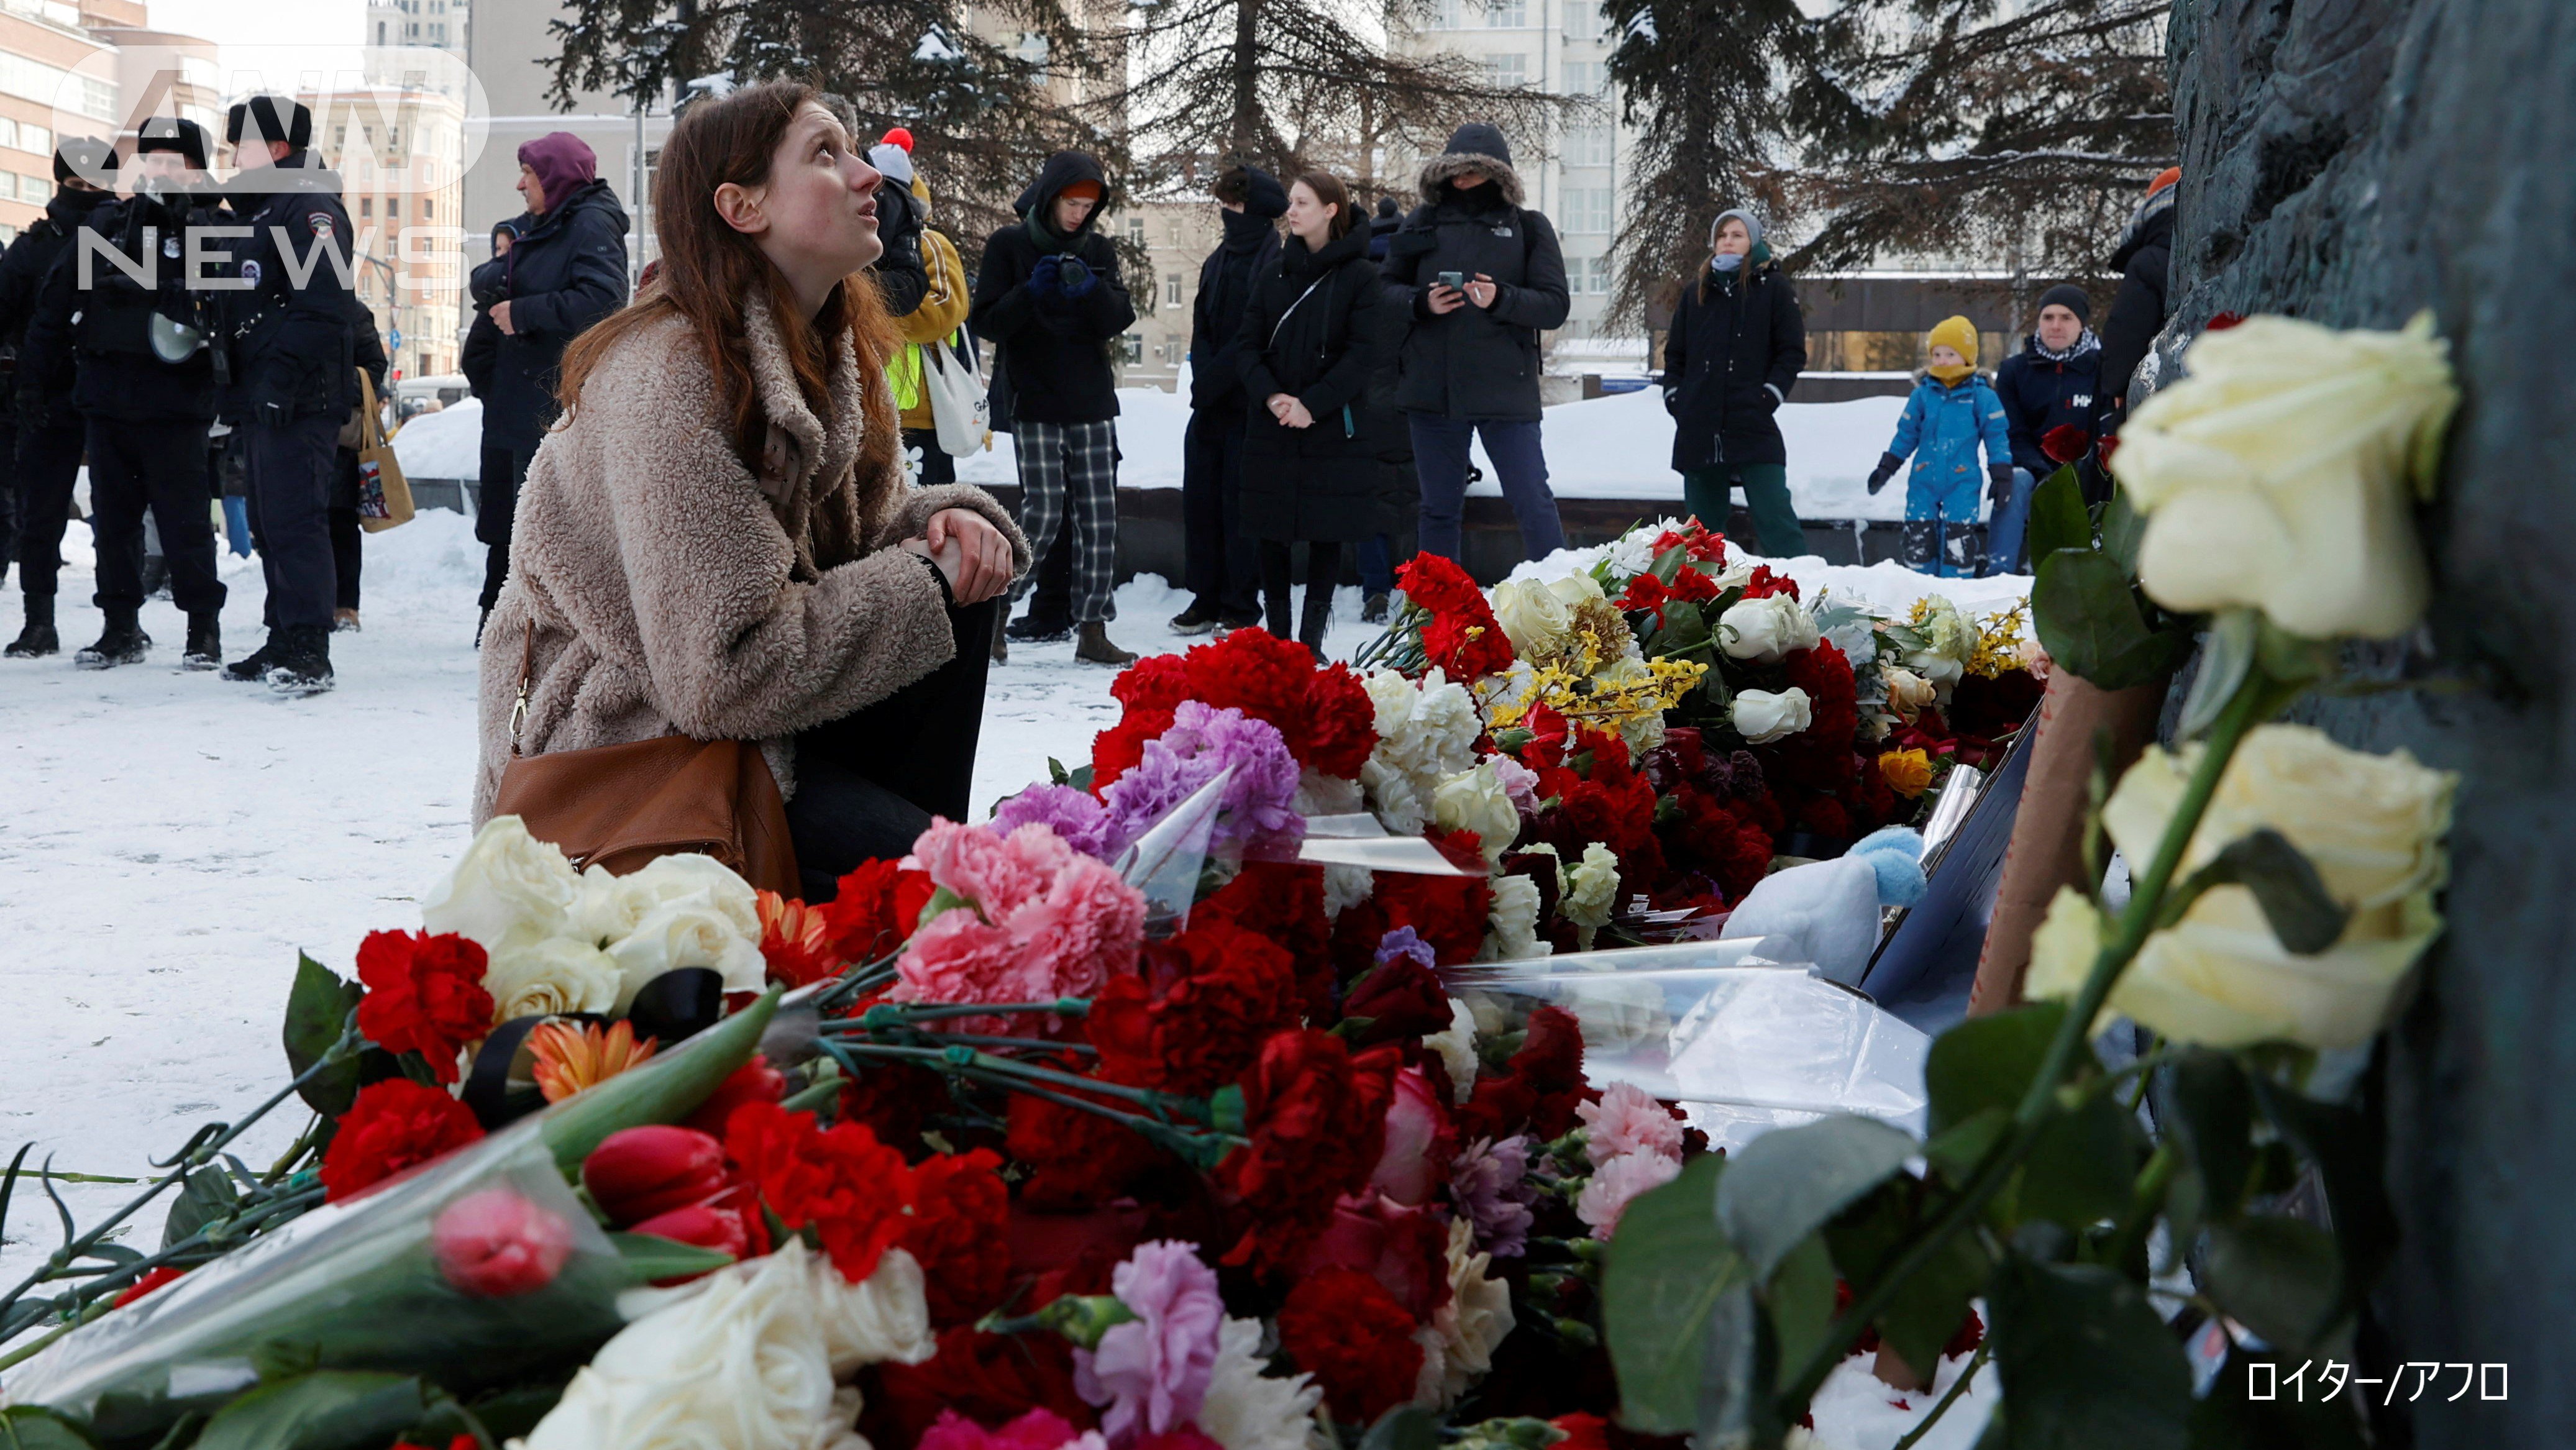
[1172,165,1288,634]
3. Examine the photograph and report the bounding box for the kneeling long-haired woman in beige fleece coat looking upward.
[474,83,1028,899]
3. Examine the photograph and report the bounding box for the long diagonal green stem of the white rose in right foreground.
[1783,667,2280,1407]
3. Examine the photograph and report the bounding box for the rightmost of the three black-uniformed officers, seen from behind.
[222,95,358,695]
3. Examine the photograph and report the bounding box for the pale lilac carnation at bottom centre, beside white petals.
[1074,1241,1226,1445]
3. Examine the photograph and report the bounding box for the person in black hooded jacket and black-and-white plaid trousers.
[971,152,1136,665]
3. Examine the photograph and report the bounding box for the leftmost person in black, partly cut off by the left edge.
[0,137,116,659]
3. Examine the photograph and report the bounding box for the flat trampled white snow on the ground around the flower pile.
[0,509,2027,1303]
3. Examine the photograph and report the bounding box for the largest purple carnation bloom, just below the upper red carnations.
[1105,701,1306,855]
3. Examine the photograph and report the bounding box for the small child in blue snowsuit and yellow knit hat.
[1870,317,2012,577]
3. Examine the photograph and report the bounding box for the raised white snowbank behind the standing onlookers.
[394,389,1937,518]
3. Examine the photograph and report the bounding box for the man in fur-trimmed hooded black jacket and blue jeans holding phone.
[1386,121,1571,559]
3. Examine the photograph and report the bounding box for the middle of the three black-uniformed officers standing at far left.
[21,116,224,670]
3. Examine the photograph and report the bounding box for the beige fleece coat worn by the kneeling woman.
[474,299,1028,829]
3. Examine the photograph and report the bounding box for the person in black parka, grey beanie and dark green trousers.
[1661,211,1808,559]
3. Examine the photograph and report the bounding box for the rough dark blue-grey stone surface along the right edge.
[2161,0,2576,1450]
